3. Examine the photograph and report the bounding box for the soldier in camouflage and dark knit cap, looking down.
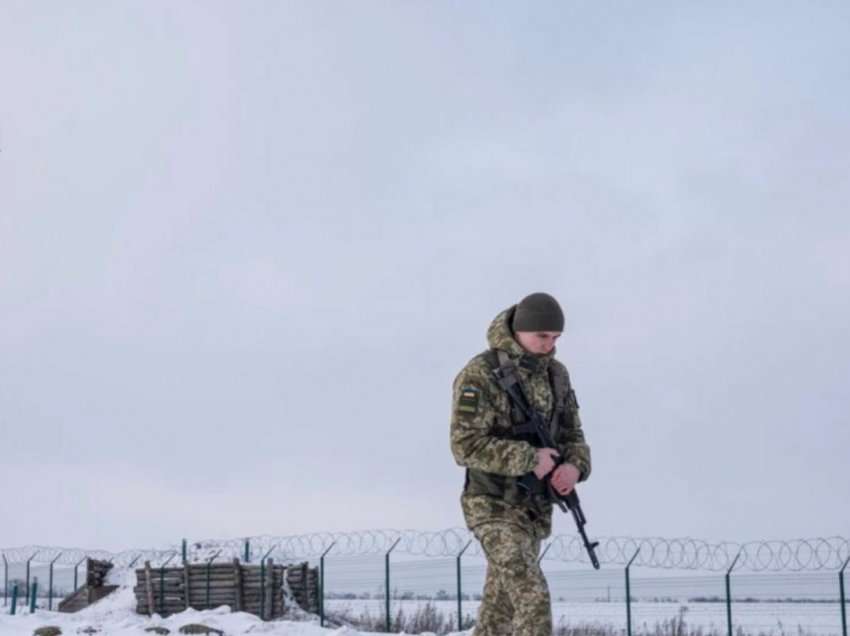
[451,293,590,636]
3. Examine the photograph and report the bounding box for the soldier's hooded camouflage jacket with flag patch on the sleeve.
[451,306,590,538]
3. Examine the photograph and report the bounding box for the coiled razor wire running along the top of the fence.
[0,528,850,572]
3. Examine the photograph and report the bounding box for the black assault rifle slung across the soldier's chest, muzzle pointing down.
[486,360,599,570]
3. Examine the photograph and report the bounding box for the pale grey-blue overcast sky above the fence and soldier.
[0,0,850,550]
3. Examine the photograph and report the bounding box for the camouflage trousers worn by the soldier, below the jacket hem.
[473,522,552,636]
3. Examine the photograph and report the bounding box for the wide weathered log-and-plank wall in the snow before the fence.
[133,559,319,620]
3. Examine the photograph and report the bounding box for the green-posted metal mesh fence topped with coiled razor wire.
[0,529,850,636]
